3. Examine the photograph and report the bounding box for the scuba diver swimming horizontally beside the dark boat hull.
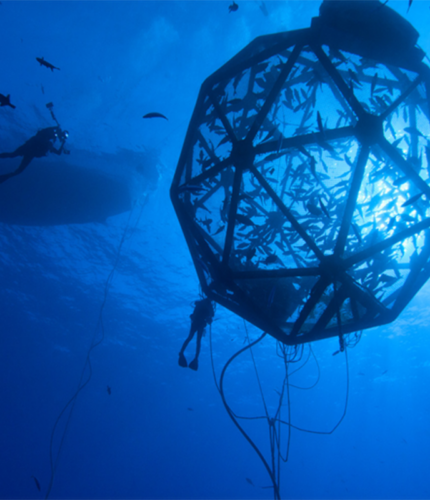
[0,126,69,184]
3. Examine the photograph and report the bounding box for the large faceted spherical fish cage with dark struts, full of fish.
[171,0,430,345]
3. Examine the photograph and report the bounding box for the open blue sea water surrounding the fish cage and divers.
[0,0,430,500]
